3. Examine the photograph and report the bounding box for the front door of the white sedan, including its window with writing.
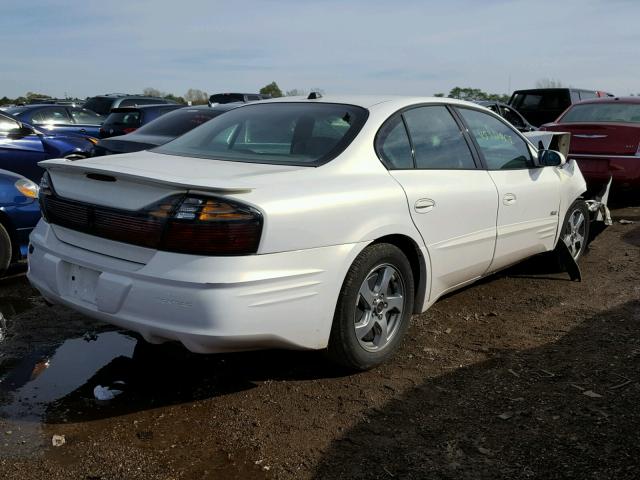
[457,108,561,271]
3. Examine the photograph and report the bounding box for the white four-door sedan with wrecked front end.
[28,94,589,369]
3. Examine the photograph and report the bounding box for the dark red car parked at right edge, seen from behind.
[540,97,640,189]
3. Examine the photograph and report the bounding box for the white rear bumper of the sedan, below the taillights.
[27,221,361,353]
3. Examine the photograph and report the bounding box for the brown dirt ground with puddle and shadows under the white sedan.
[0,207,640,480]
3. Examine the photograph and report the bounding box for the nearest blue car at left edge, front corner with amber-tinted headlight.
[0,168,40,273]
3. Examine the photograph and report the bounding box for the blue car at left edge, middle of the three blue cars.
[0,113,97,183]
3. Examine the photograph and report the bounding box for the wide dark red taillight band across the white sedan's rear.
[40,186,262,255]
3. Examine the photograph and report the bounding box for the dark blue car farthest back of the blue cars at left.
[4,104,105,137]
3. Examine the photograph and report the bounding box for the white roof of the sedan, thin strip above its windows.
[255,95,477,109]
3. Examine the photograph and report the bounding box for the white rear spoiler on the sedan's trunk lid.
[38,158,253,194]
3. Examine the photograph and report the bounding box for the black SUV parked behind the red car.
[509,88,613,127]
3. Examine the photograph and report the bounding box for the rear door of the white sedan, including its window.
[377,105,498,300]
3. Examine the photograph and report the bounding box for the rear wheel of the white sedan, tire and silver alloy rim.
[327,243,414,370]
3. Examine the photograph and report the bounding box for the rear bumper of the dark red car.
[569,154,640,188]
